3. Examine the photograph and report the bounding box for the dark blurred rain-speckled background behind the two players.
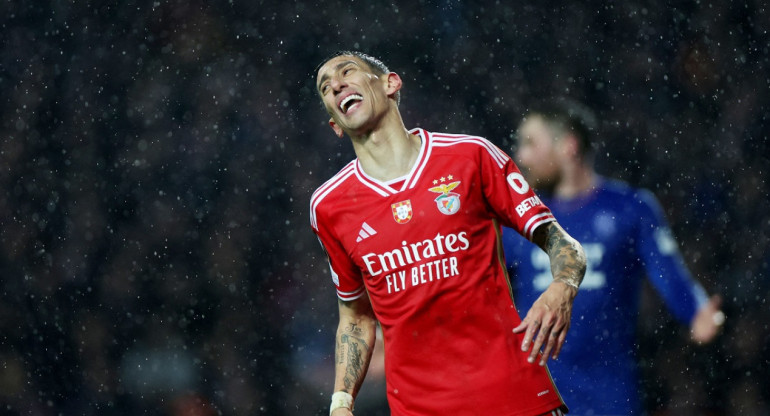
[0,0,770,416]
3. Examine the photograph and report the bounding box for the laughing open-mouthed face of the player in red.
[316,55,388,137]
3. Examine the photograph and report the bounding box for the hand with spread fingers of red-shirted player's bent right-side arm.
[513,281,577,365]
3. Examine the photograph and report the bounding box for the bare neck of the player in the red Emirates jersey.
[352,110,420,181]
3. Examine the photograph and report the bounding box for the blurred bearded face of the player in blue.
[516,115,561,188]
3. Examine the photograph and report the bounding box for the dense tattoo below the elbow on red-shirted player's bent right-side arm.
[545,224,586,289]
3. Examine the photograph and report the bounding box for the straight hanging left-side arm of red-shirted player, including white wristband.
[331,295,377,416]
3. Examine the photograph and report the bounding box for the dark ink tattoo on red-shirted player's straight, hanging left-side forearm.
[336,324,371,391]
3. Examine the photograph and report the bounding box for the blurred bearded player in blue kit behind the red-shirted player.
[503,100,724,415]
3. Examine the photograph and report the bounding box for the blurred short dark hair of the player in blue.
[527,98,597,156]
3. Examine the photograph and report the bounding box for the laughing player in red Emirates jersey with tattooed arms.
[310,52,585,416]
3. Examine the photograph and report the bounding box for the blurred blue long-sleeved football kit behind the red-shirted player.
[503,178,707,415]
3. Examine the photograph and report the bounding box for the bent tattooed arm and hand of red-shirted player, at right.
[513,221,586,365]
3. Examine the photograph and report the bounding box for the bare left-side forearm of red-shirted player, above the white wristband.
[334,308,377,396]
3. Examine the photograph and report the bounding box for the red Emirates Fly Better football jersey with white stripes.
[310,129,563,416]
